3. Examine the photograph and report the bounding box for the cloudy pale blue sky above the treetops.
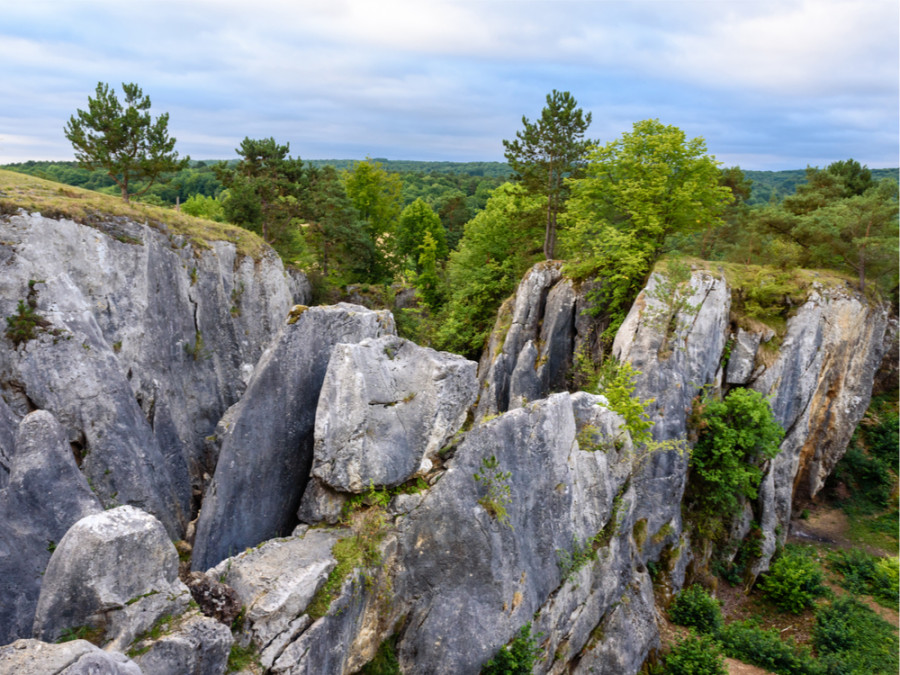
[0,0,900,170]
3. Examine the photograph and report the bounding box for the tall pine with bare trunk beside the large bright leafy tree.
[503,89,591,260]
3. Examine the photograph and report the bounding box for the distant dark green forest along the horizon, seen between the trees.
[0,157,900,215]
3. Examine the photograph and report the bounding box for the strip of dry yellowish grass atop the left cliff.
[0,169,266,259]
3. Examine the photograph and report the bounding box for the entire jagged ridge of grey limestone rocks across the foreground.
[0,209,889,675]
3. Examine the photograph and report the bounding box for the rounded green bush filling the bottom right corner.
[813,596,898,675]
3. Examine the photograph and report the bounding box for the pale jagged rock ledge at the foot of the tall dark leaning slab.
[207,528,340,672]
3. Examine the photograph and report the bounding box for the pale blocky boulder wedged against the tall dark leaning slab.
[312,336,478,493]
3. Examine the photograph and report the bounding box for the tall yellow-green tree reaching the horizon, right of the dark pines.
[344,159,403,282]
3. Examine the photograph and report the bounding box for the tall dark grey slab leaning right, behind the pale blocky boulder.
[192,304,394,570]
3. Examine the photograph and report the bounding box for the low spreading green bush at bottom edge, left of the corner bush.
[719,621,822,675]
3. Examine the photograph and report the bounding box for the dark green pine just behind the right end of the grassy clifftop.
[216,138,304,256]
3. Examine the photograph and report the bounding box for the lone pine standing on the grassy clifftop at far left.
[65,82,190,202]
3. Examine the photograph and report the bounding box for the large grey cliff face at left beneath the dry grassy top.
[0,212,305,538]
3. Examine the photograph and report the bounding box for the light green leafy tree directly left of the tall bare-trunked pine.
[435,184,545,359]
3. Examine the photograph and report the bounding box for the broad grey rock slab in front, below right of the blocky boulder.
[394,394,630,673]
